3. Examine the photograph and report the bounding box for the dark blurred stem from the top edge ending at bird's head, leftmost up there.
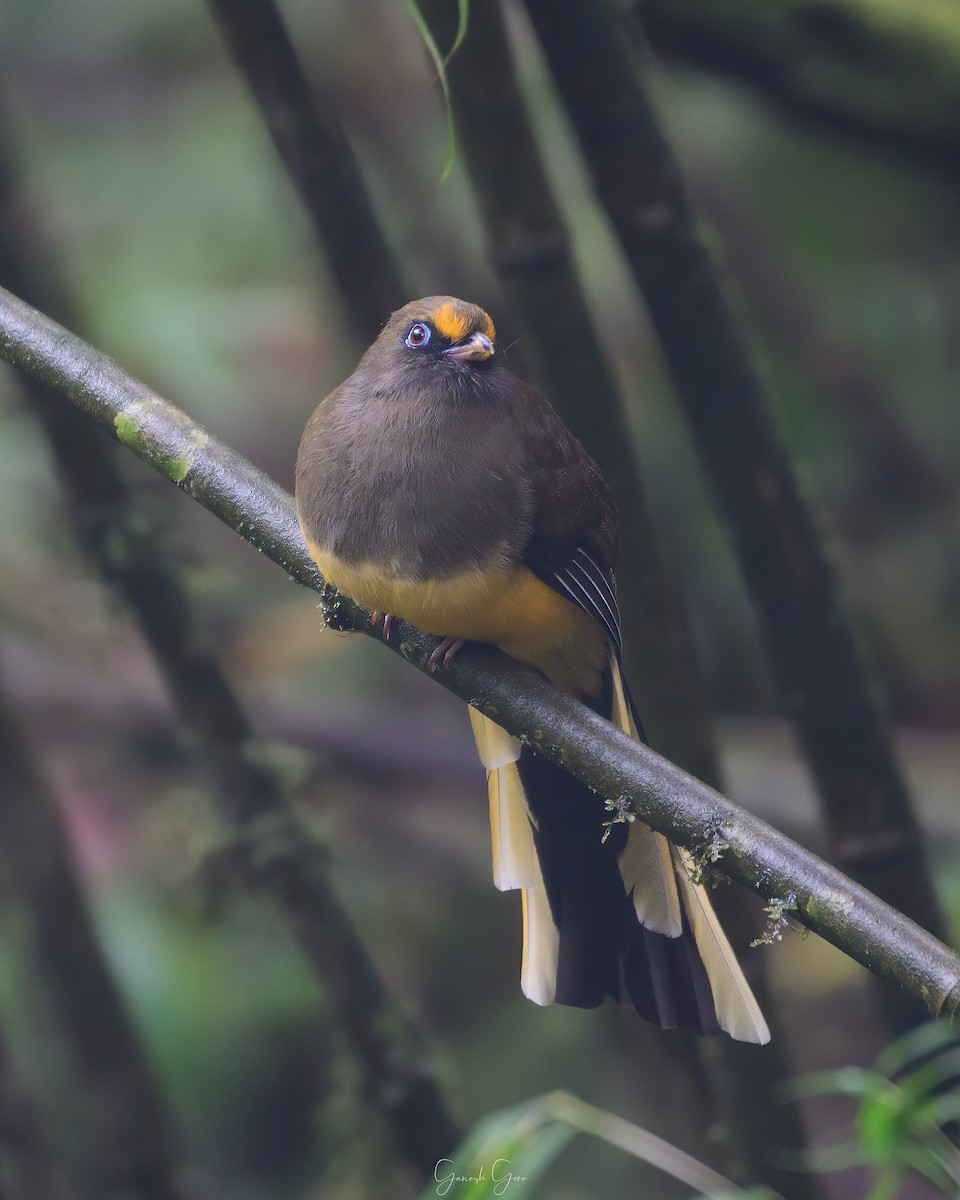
[208,0,409,344]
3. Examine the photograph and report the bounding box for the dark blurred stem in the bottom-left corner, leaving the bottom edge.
[0,696,184,1200]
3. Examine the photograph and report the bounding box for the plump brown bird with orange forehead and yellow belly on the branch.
[295,296,769,1043]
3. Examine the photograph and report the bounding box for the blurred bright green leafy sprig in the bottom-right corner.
[793,1021,960,1200]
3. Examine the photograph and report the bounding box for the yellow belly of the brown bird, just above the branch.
[307,539,608,696]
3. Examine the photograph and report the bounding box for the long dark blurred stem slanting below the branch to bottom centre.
[0,136,458,1176]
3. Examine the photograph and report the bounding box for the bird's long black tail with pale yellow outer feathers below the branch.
[470,655,769,1043]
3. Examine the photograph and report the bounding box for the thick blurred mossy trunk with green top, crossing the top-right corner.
[635,0,960,180]
